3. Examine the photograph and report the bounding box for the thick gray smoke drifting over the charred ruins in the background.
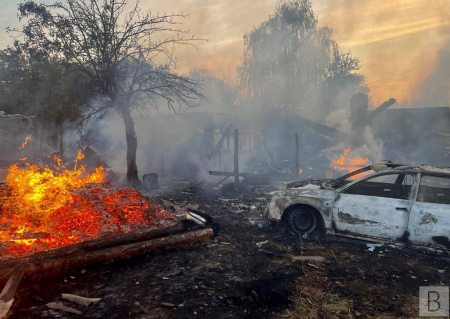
[76,2,450,184]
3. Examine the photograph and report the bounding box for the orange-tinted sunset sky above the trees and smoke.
[0,0,450,105]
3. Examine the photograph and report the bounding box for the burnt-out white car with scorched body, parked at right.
[268,163,450,249]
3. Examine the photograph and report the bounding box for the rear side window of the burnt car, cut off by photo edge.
[416,175,450,204]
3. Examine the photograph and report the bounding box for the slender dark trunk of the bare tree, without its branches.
[119,98,140,187]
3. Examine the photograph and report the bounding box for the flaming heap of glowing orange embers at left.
[0,153,175,257]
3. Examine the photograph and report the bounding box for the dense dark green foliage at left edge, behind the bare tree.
[0,42,90,124]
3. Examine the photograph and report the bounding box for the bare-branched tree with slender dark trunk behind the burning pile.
[15,0,205,183]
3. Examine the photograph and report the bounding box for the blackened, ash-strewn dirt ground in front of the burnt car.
[6,181,450,319]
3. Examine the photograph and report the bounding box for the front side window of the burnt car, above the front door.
[342,174,414,199]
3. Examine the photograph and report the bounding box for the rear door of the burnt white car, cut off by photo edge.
[409,173,450,248]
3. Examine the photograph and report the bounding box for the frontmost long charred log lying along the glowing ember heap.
[0,228,214,282]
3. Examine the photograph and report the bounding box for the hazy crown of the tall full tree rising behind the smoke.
[238,0,364,117]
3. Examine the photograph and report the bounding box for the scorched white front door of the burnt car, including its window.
[333,173,414,239]
